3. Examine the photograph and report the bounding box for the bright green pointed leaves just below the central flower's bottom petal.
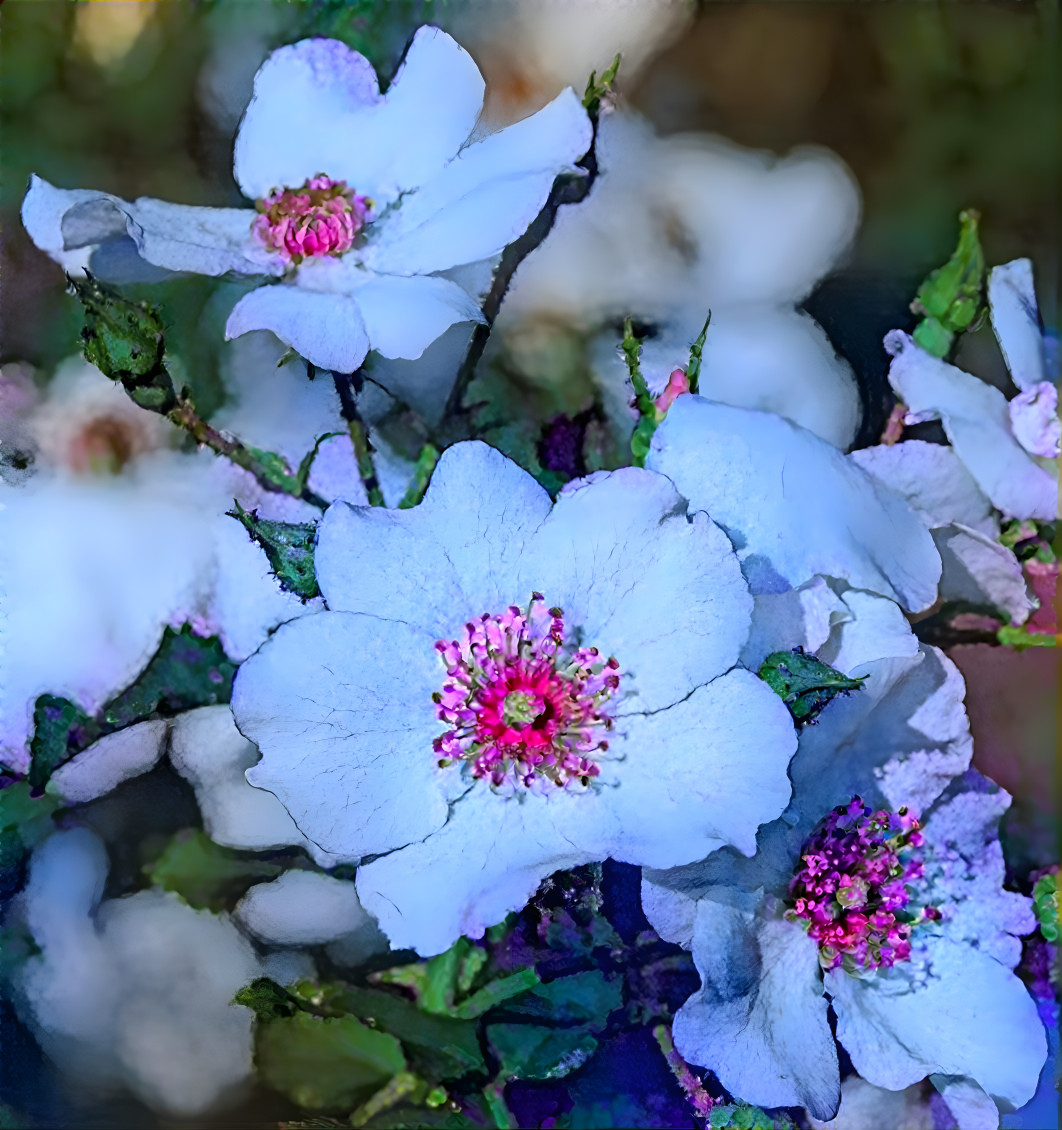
[375,938,539,1020]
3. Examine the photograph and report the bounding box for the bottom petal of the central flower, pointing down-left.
[357,782,595,957]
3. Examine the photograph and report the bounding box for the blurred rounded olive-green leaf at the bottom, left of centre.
[255,1012,406,1110]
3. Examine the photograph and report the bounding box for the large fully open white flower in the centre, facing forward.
[233,443,795,955]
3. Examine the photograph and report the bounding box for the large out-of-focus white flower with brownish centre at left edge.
[0,360,332,771]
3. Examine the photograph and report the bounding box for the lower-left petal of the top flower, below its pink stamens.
[225,284,369,373]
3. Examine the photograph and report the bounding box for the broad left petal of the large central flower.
[232,612,446,860]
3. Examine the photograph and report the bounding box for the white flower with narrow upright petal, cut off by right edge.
[885,259,1062,521]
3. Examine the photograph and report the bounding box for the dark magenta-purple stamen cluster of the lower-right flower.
[786,797,940,972]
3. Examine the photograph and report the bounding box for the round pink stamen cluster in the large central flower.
[433,592,619,788]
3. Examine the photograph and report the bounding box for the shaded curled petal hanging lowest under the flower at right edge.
[933,523,1034,624]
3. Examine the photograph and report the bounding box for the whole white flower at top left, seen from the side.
[23,27,591,372]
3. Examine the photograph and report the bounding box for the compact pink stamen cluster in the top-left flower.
[252,173,373,266]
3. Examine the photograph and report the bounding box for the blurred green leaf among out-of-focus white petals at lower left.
[143,828,284,911]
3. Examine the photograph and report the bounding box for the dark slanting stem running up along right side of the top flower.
[439,70,600,431]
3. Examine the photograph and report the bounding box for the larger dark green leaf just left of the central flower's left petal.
[104,625,236,728]
